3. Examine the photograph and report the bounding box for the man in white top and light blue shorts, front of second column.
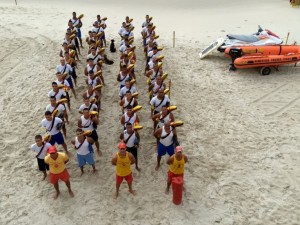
[71,128,96,176]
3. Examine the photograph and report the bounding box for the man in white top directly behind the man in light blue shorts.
[77,108,102,156]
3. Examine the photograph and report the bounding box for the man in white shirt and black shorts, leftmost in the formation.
[31,135,52,180]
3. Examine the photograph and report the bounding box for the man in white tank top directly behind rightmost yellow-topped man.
[154,121,178,170]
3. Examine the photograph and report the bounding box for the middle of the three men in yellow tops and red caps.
[111,142,136,198]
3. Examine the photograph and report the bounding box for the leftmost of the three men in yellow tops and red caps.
[45,146,74,199]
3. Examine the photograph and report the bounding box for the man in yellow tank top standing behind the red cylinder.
[165,146,188,194]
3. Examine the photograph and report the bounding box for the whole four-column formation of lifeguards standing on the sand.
[31,12,187,199]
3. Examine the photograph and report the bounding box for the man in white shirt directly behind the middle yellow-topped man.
[120,123,140,171]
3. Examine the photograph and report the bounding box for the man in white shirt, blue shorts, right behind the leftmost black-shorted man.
[41,111,69,154]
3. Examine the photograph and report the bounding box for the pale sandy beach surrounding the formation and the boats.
[0,0,300,225]
